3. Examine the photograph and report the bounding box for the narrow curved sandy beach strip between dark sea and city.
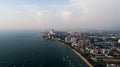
[56,41,94,67]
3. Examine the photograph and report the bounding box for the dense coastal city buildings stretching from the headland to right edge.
[43,30,120,67]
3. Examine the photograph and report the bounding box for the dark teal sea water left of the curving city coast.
[0,31,88,67]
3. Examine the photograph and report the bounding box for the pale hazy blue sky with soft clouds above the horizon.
[0,0,120,30]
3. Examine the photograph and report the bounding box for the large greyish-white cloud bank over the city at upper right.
[70,0,120,29]
